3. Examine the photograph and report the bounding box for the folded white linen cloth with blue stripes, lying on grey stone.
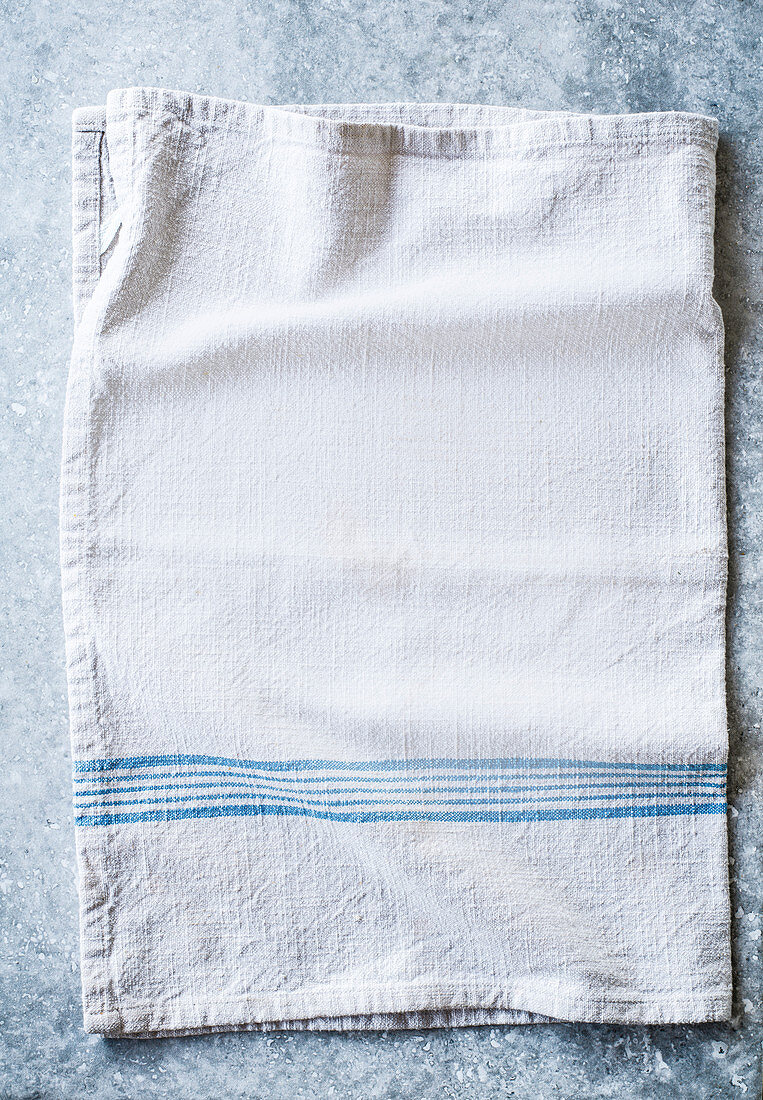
[62,88,730,1035]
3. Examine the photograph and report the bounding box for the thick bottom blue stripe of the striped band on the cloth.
[76,803,727,826]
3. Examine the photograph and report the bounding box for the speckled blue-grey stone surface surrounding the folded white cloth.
[0,0,763,1100]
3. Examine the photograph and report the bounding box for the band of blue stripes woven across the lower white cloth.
[74,754,726,826]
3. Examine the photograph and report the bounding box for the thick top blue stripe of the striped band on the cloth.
[74,754,726,772]
